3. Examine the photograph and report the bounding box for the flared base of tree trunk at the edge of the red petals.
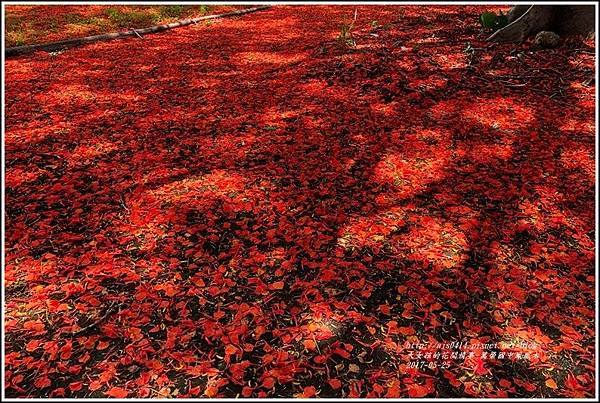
[488,5,596,42]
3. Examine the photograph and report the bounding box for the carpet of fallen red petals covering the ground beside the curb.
[5,6,595,397]
